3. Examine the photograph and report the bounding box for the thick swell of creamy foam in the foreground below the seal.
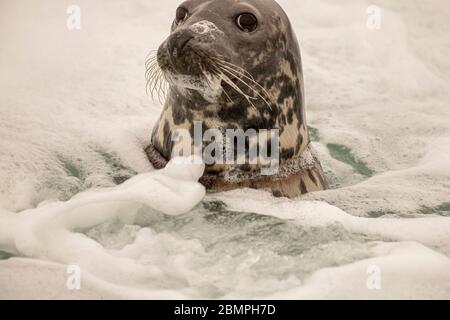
[0,188,450,299]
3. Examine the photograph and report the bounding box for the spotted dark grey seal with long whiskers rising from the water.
[147,0,327,197]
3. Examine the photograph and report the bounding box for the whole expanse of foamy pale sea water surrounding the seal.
[0,0,450,299]
